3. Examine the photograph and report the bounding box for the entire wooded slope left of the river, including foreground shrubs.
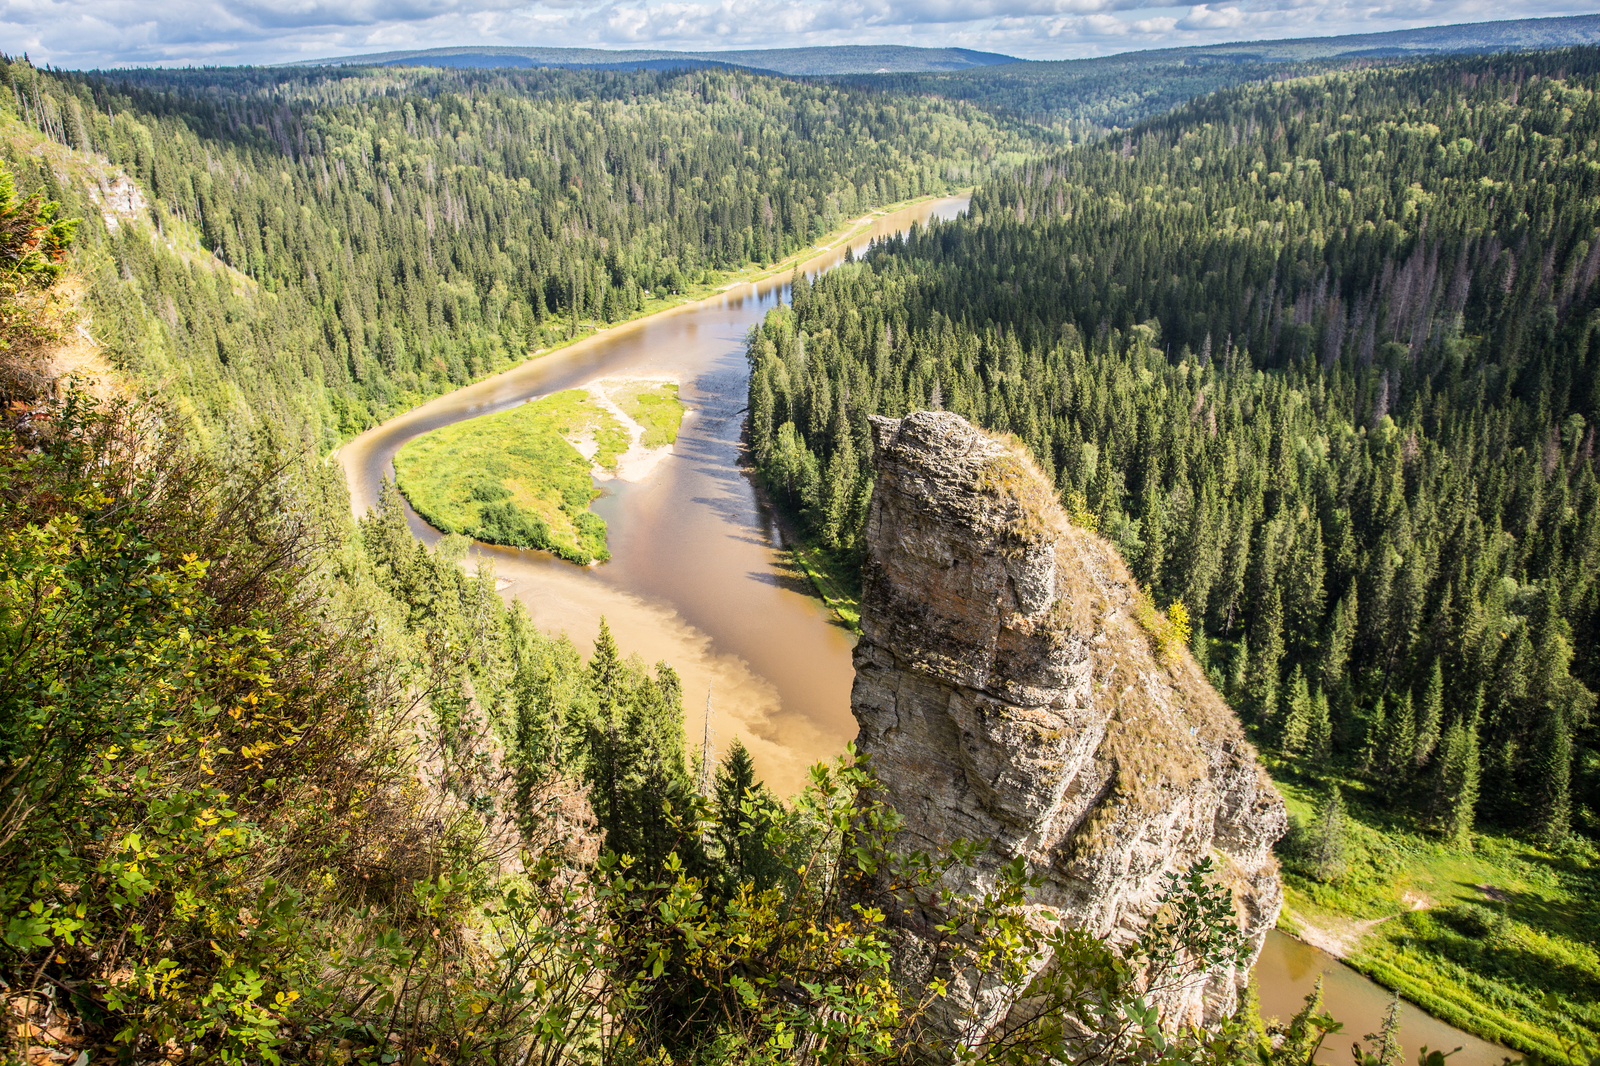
[0,49,1324,1066]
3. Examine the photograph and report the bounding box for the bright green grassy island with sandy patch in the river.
[395,379,683,563]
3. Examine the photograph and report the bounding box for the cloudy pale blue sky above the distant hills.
[0,0,1600,69]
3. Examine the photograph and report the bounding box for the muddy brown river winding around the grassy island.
[338,197,1504,1066]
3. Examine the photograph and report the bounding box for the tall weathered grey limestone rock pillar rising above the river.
[851,411,1286,1037]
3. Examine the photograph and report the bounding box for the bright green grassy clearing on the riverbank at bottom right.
[1267,745,1600,1061]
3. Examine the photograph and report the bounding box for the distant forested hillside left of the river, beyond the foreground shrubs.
[0,62,1040,450]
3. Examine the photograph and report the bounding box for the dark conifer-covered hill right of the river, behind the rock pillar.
[750,50,1600,839]
